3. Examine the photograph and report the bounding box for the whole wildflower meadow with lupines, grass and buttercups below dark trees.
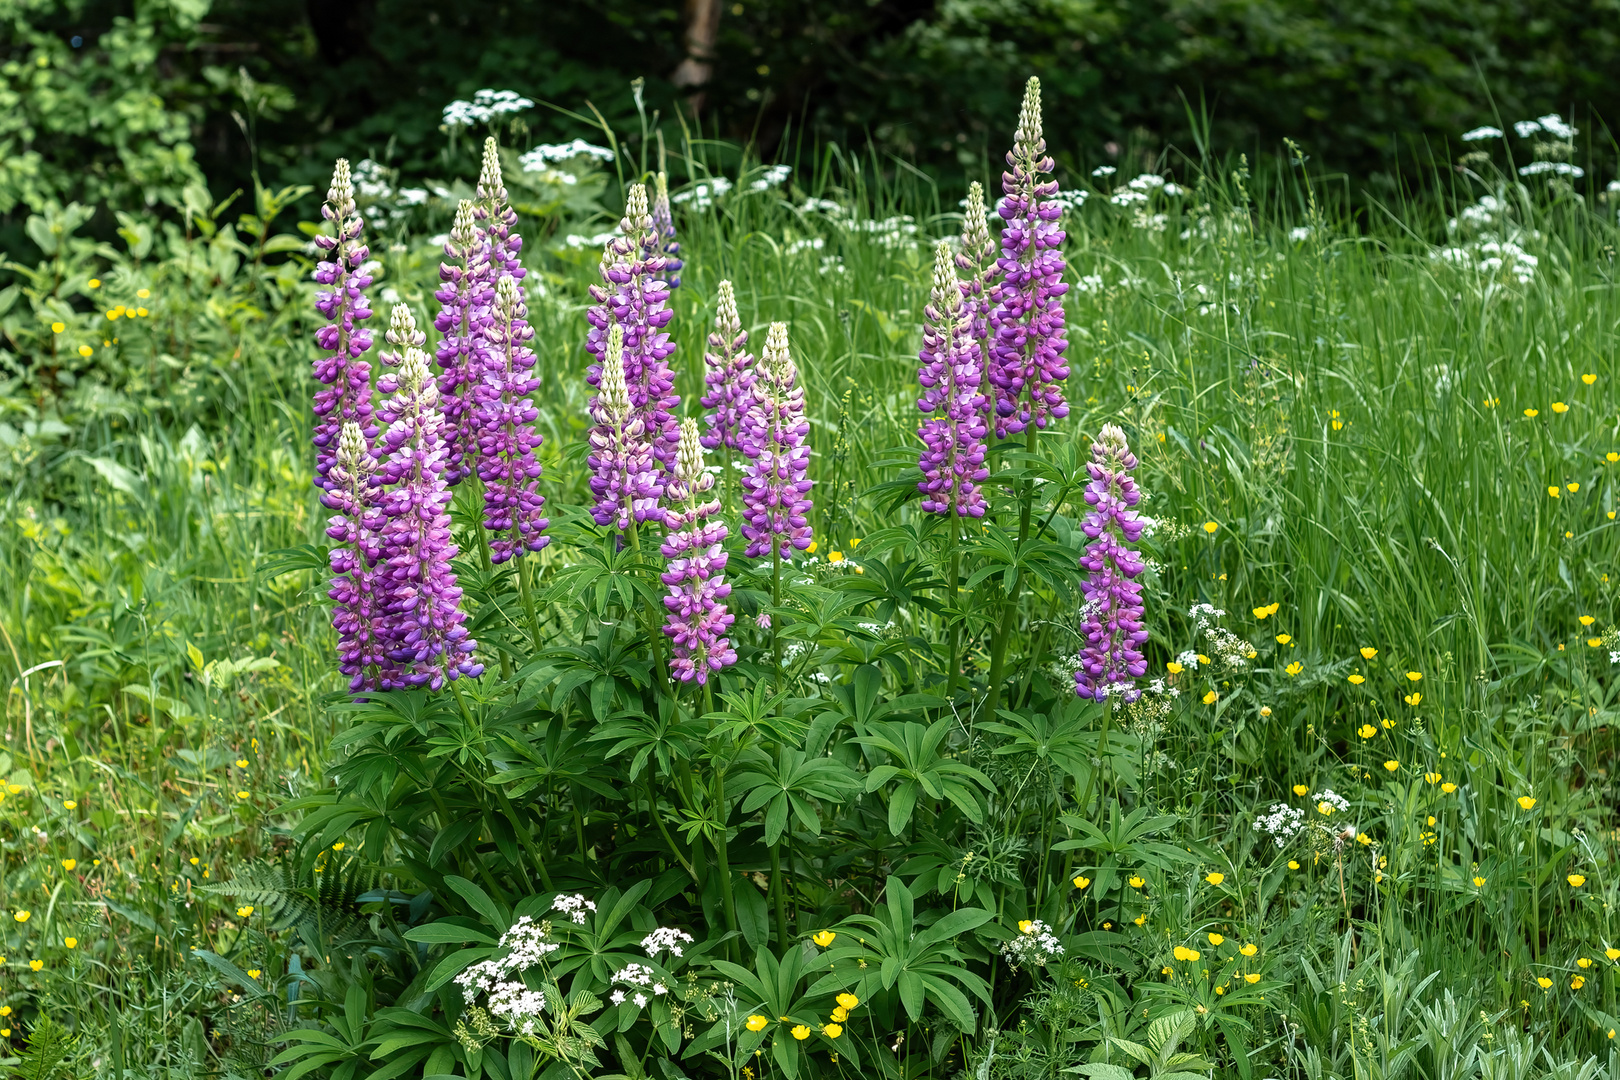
[0,74,1620,1080]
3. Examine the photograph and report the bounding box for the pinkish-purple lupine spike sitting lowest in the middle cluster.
[659,418,737,685]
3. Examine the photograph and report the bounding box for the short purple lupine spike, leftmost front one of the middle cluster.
[585,322,664,533]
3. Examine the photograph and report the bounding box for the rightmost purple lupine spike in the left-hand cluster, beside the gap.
[478,274,551,562]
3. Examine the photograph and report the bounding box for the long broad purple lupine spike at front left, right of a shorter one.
[376,348,484,690]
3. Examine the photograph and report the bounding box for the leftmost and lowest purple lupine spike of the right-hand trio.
[917,240,990,518]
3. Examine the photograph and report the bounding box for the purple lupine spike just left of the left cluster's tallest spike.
[433,199,494,484]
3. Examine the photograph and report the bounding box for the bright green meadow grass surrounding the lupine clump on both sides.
[0,137,1620,1080]
